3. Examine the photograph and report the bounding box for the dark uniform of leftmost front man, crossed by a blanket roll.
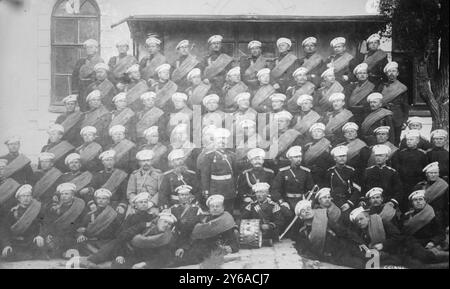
[0,200,45,261]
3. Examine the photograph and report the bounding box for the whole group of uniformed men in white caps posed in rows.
[0,34,449,268]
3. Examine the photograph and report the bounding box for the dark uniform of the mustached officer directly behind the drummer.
[237,167,275,208]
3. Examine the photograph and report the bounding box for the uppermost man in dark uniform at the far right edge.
[427,129,448,179]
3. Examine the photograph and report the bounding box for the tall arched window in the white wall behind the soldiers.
[51,0,100,105]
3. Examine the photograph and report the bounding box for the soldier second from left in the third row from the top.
[81,90,111,147]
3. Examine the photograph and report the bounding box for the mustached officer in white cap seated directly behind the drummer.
[237,148,275,208]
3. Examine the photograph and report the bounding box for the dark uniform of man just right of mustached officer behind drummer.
[271,166,314,210]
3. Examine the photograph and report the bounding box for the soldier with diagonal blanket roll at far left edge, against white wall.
[0,136,33,184]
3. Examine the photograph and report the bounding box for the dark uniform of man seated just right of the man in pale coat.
[159,170,200,208]
